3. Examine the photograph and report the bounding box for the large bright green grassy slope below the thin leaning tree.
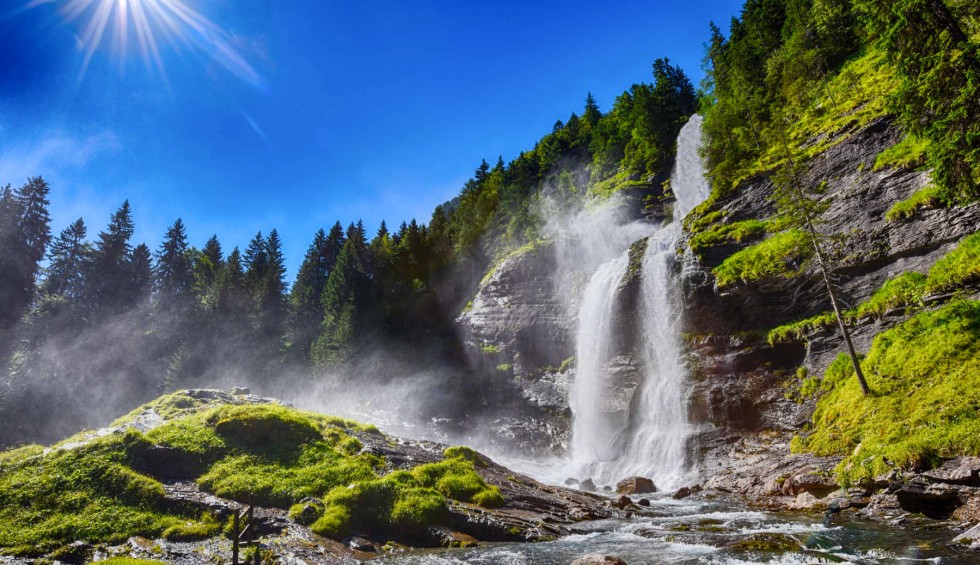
[792,301,980,485]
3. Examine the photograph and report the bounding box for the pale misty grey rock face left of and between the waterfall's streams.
[456,236,646,455]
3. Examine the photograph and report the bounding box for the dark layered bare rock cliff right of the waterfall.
[682,119,980,519]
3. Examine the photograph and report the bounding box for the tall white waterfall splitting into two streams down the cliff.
[569,115,710,489]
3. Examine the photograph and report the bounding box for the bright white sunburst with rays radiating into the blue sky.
[27,0,265,90]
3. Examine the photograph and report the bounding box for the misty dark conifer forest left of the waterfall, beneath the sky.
[0,59,697,444]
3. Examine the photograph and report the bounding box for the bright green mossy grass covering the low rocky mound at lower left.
[0,393,503,555]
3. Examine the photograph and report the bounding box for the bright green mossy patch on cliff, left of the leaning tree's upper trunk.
[714,229,811,287]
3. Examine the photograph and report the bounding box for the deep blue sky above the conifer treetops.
[0,0,742,280]
